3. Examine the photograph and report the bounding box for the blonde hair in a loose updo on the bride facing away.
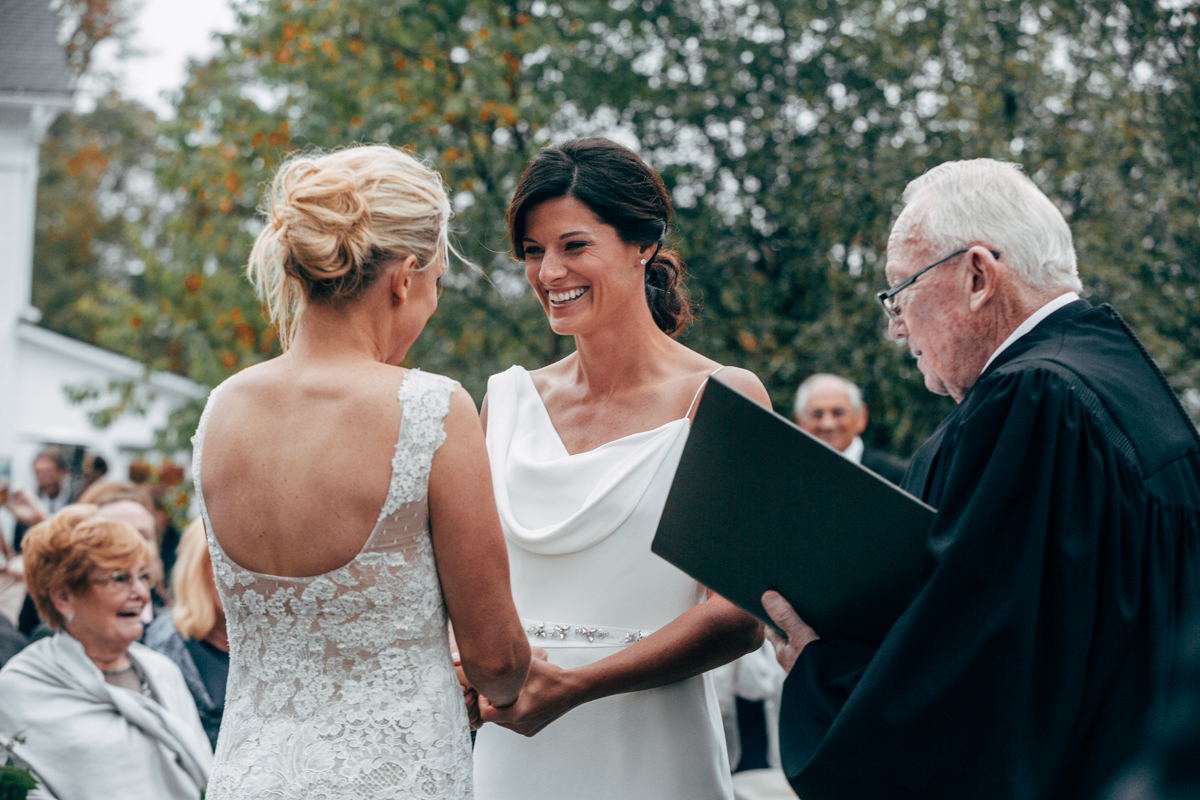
[246,144,451,350]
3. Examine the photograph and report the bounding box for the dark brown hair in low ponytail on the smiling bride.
[508,137,692,336]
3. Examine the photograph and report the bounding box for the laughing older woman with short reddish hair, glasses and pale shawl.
[0,505,212,800]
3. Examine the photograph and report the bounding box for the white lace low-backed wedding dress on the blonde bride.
[192,369,472,800]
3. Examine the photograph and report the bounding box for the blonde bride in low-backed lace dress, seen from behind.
[193,145,529,800]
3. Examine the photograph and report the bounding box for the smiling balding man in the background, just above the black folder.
[792,373,908,483]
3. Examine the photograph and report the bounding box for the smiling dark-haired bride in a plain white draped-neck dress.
[475,139,769,800]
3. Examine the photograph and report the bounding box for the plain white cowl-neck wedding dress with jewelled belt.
[475,367,733,800]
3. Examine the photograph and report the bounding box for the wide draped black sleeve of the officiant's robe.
[781,368,1144,800]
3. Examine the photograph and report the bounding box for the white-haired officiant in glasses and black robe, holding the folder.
[763,160,1200,800]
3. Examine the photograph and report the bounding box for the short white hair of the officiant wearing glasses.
[890,158,1081,291]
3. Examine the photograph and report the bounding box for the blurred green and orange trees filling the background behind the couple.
[35,0,1200,456]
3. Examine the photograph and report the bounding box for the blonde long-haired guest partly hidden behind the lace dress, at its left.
[145,519,229,750]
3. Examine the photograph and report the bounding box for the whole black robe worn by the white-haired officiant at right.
[780,301,1200,800]
